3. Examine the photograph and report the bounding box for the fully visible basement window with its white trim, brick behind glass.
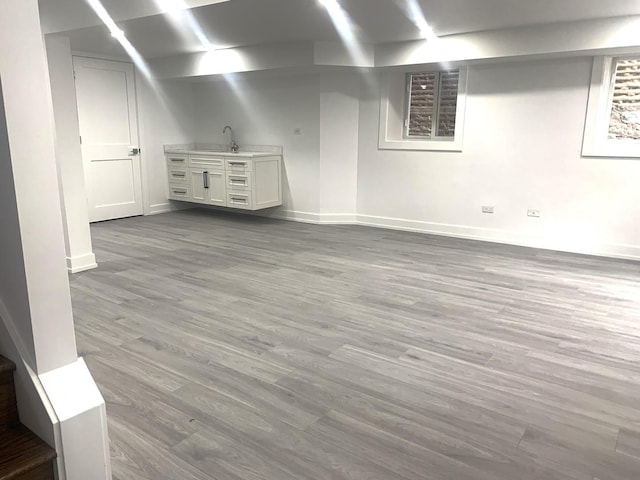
[378,63,467,151]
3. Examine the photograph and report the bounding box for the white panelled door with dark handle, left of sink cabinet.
[73,57,143,222]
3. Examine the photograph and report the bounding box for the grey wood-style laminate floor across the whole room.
[71,210,640,480]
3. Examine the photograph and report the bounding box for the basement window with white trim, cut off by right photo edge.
[582,56,640,158]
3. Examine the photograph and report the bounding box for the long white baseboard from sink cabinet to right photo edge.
[270,210,640,260]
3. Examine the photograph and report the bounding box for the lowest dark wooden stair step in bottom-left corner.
[0,425,56,480]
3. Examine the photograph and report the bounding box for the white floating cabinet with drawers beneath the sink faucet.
[167,152,282,210]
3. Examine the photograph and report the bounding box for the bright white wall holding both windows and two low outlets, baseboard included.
[358,58,640,257]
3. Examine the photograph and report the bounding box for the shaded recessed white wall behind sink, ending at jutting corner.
[194,75,320,215]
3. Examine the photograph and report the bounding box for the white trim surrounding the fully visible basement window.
[378,66,468,152]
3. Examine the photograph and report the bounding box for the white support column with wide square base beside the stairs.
[0,0,111,480]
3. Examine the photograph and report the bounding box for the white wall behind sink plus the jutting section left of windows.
[194,70,360,219]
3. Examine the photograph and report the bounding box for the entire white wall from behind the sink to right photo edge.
[186,57,640,257]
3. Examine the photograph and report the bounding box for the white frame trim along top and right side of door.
[71,50,154,216]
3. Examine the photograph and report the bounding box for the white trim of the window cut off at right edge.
[582,54,640,158]
